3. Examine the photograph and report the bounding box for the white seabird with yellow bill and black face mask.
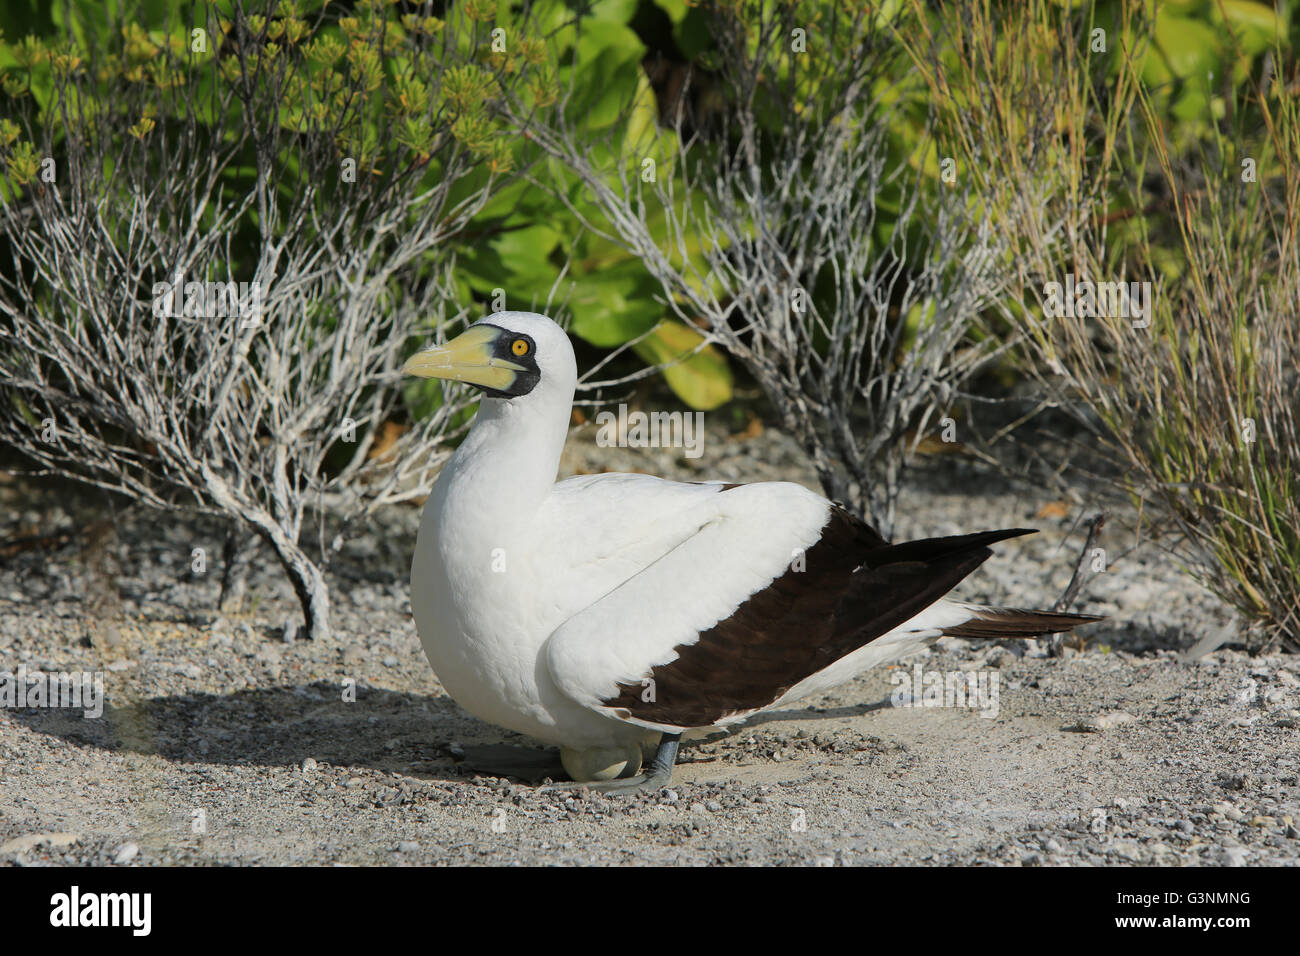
[403,312,1097,790]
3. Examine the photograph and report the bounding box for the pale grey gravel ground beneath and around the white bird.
[0,416,1300,866]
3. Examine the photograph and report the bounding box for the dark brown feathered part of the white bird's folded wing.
[606,507,1031,727]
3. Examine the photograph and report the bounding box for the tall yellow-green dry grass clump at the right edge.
[913,4,1300,649]
